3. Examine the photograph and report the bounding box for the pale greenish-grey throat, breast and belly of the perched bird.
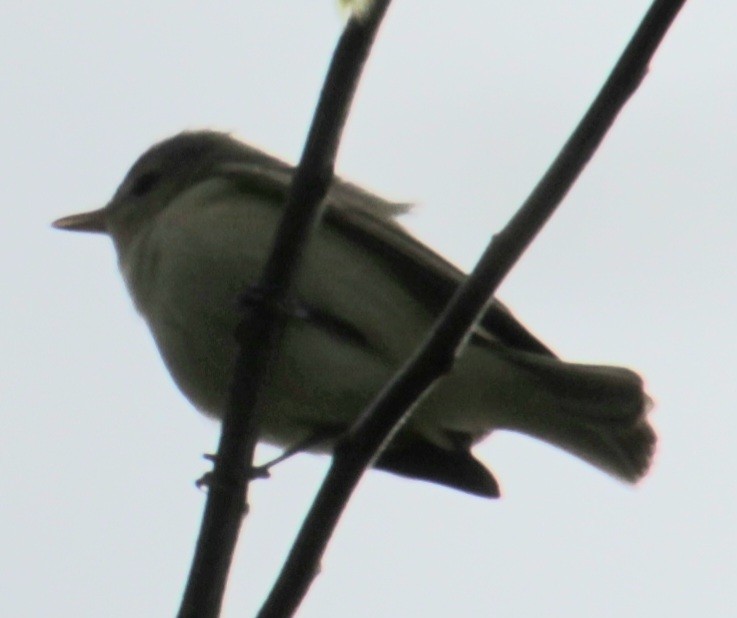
[121,195,466,445]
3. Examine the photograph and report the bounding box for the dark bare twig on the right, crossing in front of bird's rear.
[259,0,685,618]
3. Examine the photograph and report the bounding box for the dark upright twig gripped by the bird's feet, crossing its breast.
[178,0,390,618]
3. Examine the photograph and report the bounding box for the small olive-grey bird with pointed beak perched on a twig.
[53,131,655,497]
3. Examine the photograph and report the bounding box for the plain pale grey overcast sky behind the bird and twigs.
[0,0,737,618]
